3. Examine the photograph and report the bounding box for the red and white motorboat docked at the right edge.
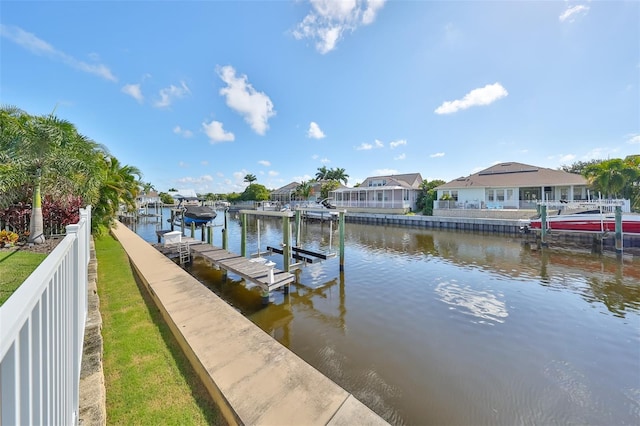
[521,203,640,234]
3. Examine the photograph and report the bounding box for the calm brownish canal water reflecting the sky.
[132,214,640,425]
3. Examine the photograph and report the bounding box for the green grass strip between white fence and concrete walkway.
[95,235,225,425]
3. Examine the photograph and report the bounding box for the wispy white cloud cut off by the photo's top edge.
[293,0,386,54]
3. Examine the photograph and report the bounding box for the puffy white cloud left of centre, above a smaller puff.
[217,65,276,135]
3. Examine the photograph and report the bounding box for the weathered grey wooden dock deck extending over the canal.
[190,244,295,291]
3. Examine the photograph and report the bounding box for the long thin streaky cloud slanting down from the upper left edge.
[0,24,118,81]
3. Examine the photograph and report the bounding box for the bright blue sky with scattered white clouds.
[0,0,640,193]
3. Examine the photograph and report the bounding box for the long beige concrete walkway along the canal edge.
[112,222,387,426]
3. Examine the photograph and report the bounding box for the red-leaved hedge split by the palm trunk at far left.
[0,196,82,241]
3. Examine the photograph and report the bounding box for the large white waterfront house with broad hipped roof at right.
[433,162,590,216]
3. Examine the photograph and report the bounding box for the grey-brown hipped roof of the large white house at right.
[436,162,587,189]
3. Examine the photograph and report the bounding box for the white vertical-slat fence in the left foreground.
[0,206,91,425]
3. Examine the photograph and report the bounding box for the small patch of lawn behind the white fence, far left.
[0,250,47,306]
